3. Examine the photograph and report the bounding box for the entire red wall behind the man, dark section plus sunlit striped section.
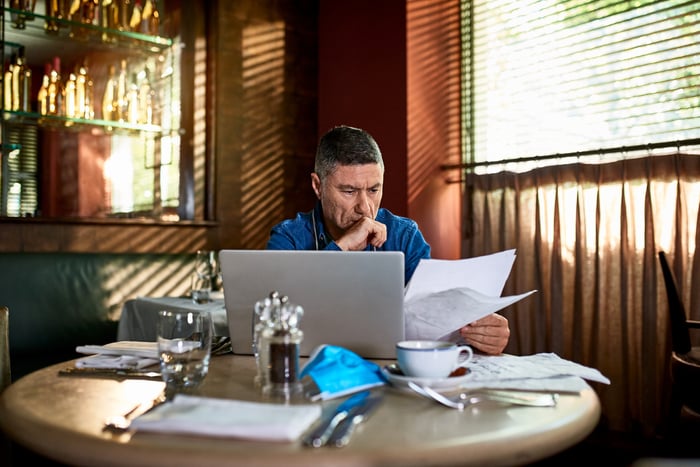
[318,0,461,259]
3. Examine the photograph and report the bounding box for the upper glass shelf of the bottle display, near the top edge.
[2,6,173,52]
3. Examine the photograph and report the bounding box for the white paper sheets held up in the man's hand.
[404,249,536,339]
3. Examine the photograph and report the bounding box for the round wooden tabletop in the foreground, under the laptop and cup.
[0,355,600,467]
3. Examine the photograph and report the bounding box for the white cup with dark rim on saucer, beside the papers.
[396,340,474,378]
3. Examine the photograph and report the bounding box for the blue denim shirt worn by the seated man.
[267,202,430,284]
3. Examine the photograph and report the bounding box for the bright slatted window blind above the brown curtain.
[462,0,700,172]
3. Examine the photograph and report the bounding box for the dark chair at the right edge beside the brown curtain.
[659,251,700,427]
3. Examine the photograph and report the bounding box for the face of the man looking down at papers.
[311,164,384,239]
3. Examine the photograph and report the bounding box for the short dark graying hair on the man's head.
[314,125,384,182]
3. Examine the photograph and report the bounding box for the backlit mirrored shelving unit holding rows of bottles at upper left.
[0,2,182,219]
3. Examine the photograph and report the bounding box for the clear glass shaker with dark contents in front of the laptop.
[258,292,304,400]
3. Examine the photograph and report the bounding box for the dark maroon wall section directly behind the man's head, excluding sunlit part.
[318,0,408,216]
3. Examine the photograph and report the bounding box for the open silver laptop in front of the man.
[219,250,404,359]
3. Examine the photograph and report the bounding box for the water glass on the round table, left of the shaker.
[158,310,213,397]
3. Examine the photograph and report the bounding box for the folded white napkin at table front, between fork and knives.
[131,394,321,441]
